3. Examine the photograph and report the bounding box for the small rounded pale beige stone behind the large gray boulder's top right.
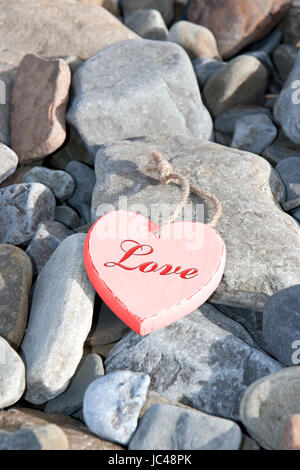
[168,21,221,60]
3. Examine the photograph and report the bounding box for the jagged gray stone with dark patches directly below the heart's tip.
[105,304,282,419]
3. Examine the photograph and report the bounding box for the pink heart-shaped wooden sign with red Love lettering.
[84,211,226,336]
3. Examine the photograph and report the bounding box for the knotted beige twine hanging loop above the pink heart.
[146,151,222,227]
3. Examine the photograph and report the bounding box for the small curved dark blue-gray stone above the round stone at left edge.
[23,166,75,202]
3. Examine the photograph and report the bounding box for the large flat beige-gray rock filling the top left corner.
[0,0,137,66]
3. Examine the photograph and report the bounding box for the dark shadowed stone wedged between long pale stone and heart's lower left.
[87,303,130,346]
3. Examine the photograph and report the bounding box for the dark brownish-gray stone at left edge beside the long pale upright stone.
[0,244,32,349]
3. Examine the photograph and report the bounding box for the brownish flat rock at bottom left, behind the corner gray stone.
[0,408,122,450]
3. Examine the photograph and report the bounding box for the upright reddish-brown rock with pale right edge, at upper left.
[11,54,71,163]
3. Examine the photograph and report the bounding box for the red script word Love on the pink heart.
[104,240,198,279]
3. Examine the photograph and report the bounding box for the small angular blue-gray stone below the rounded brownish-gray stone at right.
[231,114,277,155]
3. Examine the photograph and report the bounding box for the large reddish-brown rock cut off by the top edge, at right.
[187,0,290,59]
